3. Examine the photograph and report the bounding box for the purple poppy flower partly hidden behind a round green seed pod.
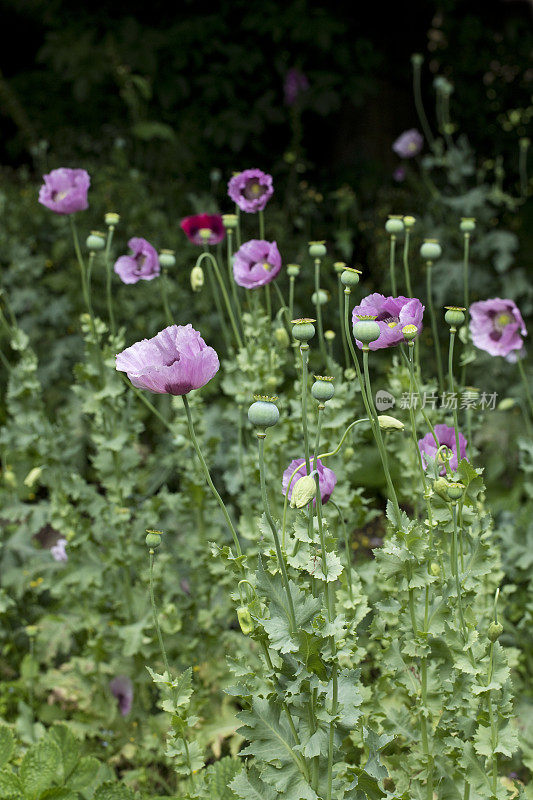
[352,292,425,350]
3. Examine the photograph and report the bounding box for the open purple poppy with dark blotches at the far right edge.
[470,297,527,356]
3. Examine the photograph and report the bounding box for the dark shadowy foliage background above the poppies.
[0,0,533,199]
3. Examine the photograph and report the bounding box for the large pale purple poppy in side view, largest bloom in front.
[116,325,220,395]
